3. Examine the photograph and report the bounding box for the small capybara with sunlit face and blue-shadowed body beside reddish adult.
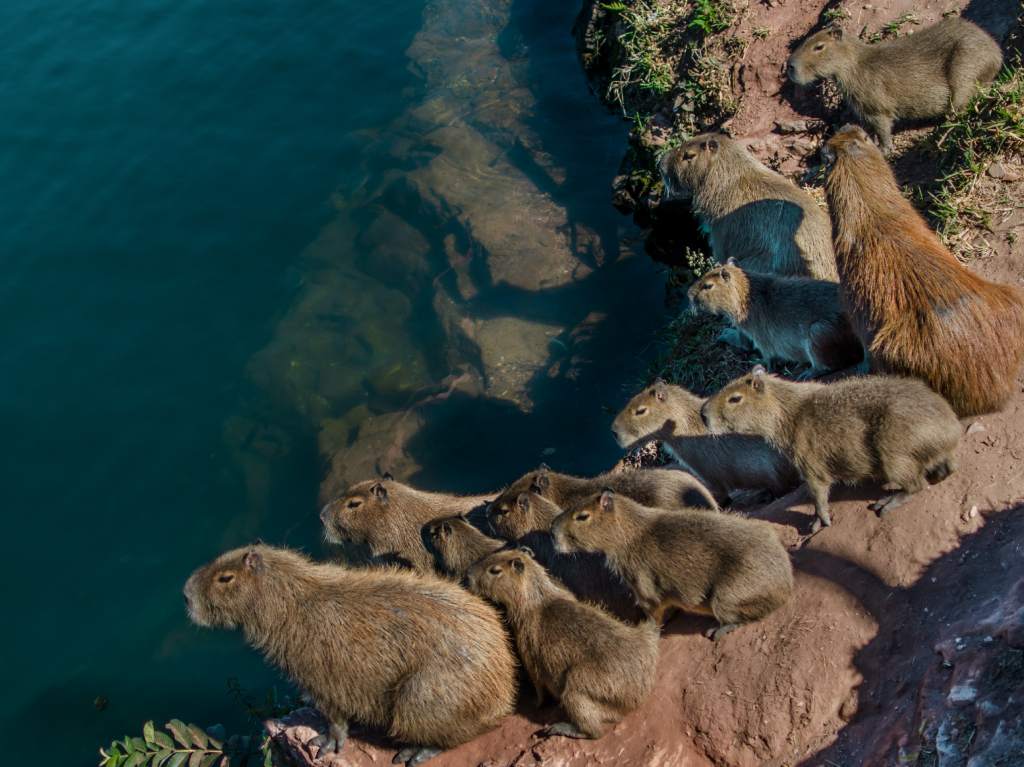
[689,258,864,378]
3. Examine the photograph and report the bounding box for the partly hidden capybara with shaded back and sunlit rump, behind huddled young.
[488,465,718,539]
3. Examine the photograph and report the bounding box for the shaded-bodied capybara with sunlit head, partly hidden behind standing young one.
[611,380,800,504]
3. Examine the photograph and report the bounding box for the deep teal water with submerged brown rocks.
[0,0,663,765]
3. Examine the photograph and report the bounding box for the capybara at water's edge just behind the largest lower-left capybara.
[321,479,486,572]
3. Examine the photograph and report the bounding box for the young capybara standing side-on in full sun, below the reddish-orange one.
[702,366,961,530]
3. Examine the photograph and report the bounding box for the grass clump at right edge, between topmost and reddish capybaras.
[926,67,1024,242]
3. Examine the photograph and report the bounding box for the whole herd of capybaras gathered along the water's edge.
[184,13,1024,765]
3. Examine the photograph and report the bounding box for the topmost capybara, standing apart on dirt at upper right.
[786,17,1002,153]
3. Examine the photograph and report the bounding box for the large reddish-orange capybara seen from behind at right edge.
[823,125,1024,416]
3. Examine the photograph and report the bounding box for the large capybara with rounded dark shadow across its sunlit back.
[658,133,837,282]
